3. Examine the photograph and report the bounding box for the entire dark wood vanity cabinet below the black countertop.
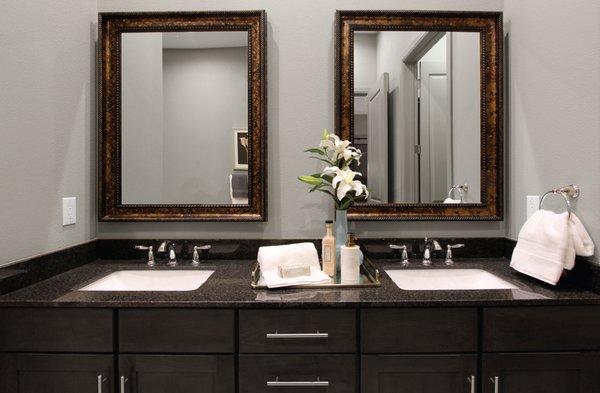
[0,306,600,393]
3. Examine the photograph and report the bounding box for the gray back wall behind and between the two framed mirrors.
[98,0,505,238]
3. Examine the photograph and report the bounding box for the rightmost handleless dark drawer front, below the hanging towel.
[483,306,600,352]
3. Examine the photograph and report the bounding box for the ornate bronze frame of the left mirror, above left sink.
[98,11,267,221]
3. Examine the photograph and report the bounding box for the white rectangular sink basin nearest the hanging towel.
[385,269,517,291]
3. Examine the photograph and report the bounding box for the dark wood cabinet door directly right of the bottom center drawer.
[362,355,477,393]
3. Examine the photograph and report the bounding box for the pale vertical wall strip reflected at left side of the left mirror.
[121,33,163,203]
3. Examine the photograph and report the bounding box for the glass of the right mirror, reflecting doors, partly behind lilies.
[353,31,481,204]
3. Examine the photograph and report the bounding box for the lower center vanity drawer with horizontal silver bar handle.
[239,355,357,393]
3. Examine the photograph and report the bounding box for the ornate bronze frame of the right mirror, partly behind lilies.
[335,11,504,221]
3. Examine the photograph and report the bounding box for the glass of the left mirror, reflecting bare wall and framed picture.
[121,31,251,205]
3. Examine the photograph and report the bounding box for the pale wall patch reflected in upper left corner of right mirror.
[354,33,379,90]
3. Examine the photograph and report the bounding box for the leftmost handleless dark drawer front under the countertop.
[0,308,113,353]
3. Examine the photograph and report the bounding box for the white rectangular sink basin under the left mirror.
[79,270,214,291]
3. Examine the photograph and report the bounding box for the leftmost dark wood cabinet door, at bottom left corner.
[0,354,113,393]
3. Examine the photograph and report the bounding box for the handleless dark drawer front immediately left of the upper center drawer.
[119,309,235,353]
